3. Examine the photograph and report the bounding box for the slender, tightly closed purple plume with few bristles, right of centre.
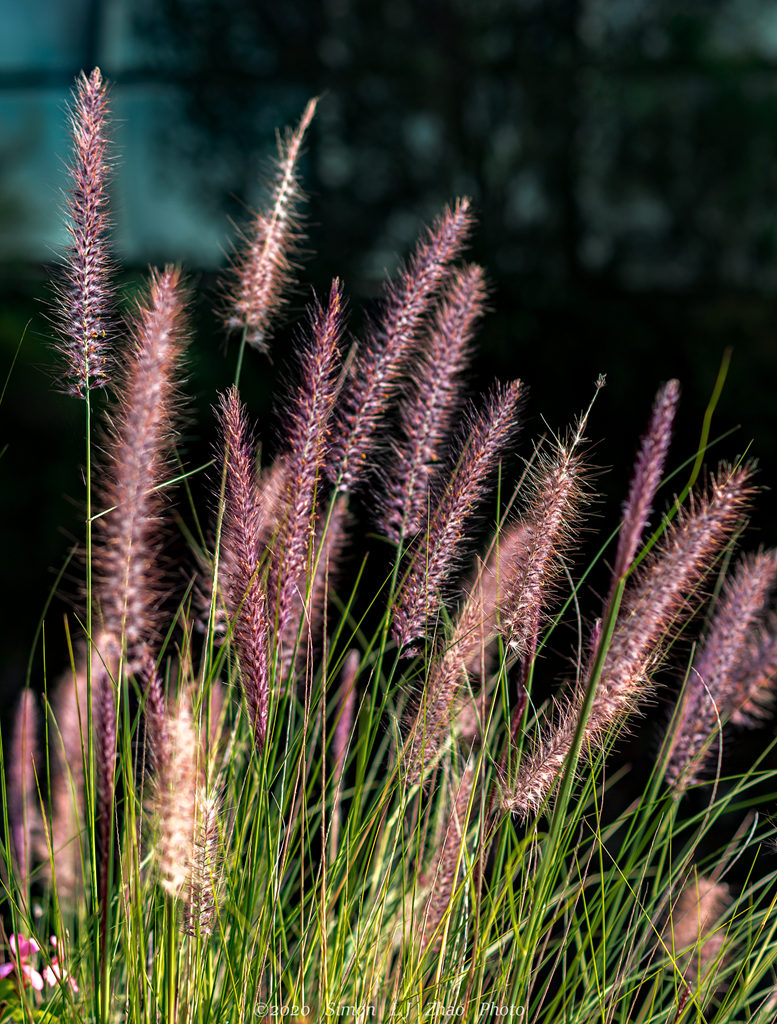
[607,380,680,603]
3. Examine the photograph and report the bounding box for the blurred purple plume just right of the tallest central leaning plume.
[380,265,485,543]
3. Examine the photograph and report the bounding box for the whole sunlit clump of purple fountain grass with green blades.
[0,71,777,1024]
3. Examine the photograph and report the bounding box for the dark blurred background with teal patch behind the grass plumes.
[0,0,777,712]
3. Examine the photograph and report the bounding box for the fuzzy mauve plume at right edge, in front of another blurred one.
[666,551,777,791]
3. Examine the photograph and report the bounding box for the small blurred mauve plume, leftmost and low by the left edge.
[7,688,44,882]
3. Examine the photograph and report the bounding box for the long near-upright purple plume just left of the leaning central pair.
[269,281,343,646]
